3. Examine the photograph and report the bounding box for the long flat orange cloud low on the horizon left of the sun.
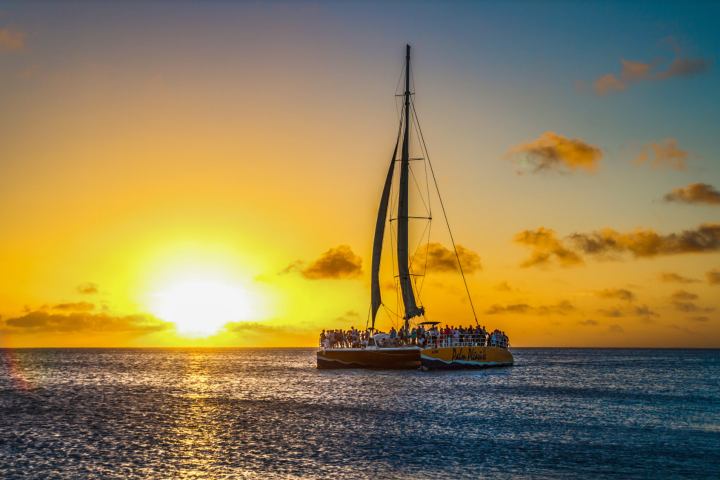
[5,310,174,334]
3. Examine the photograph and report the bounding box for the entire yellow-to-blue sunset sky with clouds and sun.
[0,1,720,348]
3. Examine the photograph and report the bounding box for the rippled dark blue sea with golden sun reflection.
[0,349,720,479]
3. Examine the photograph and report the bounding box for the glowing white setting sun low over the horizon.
[151,279,255,336]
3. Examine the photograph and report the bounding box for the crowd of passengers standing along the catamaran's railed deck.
[320,324,509,349]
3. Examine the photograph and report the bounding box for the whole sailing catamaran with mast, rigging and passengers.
[317,45,513,369]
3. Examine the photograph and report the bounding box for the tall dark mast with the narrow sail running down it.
[397,45,425,332]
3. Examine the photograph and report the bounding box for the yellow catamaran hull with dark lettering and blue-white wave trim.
[420,347,515,370]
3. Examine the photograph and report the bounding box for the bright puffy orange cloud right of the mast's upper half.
[503,132,604,173]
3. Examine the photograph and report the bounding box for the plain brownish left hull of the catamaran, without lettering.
[317,348,420,370]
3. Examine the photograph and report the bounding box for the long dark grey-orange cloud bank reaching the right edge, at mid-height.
[567,223,720,258]
